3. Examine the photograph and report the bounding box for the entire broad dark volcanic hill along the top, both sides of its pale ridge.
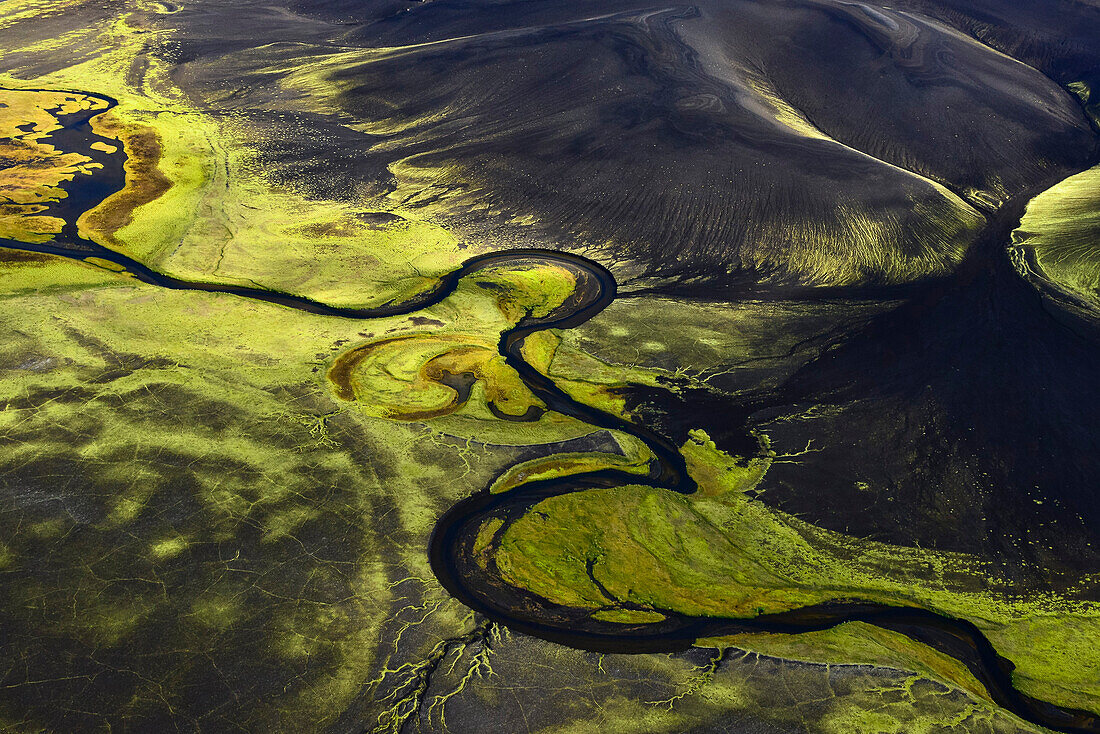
[232,0,1093,284]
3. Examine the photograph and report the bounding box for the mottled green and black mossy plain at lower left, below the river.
[0,260,486,728]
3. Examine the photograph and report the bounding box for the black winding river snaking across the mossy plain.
[0,87,1100,733]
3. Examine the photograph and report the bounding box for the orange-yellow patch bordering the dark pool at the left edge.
[0,89,107,242]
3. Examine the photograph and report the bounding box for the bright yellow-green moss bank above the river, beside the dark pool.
[0,15,473,306]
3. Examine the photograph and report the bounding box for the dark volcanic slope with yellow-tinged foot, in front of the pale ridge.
[325,11,978,284]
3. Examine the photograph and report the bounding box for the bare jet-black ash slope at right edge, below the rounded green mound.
[754,229,1100,585]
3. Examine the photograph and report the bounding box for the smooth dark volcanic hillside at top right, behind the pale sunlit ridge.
[724,2,1093,204]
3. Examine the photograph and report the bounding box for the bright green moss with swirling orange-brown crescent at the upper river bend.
[328,260,656,445]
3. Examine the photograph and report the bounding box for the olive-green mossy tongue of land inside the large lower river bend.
[496,431,1100,709]
